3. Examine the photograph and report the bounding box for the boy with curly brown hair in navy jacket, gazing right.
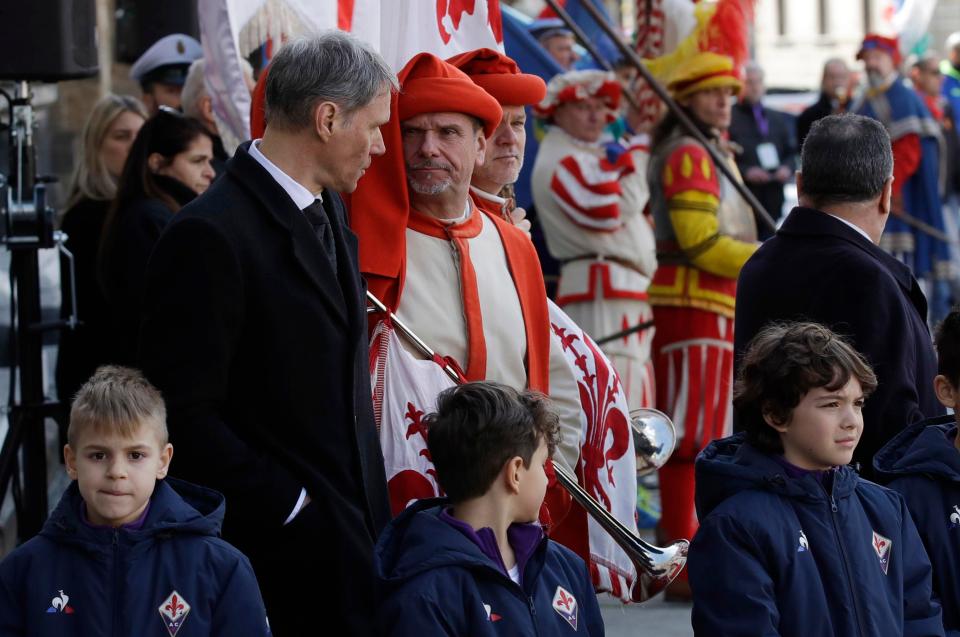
[687,323,943,637]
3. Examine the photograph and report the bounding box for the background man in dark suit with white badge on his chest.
[730,62,797,234]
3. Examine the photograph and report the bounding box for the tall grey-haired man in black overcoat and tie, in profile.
[140,32,397,637]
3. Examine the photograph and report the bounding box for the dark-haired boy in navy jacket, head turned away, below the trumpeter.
[375,382,603,637]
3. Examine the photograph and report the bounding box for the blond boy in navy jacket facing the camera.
[0,367,270,637]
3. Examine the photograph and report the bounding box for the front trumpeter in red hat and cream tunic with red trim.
[352,53,580,524]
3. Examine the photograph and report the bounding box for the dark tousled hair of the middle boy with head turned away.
[424,382,560,504]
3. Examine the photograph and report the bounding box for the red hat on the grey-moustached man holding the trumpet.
[397,53,503,137]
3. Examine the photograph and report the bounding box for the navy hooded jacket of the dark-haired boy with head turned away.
[374,499,603,637]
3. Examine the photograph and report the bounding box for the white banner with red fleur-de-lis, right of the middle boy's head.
[548,301,637,602]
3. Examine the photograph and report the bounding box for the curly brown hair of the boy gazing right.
[733,323,877,453]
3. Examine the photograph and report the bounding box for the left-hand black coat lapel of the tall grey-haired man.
[227,142,351,325]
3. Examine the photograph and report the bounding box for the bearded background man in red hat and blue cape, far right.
[851,34,950,322]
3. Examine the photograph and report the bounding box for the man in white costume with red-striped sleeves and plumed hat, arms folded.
[532,71,657,408]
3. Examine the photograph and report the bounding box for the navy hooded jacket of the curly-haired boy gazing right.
[687,434,943,637]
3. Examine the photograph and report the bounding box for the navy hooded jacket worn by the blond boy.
[0,478,270,637]
